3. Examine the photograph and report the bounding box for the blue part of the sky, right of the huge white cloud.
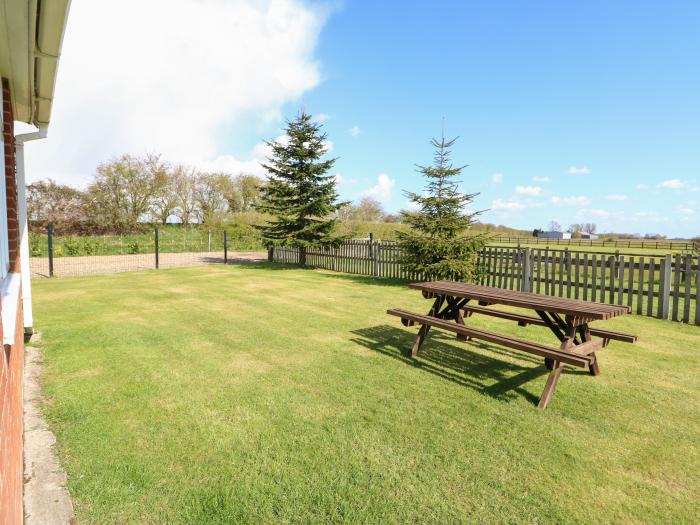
[272,1,700,236]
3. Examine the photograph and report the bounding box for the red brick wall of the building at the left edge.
[0,79,24,525]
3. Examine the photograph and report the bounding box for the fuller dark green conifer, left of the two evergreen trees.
[256,111,345,267]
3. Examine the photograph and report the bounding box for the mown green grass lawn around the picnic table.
[34,265,700,524]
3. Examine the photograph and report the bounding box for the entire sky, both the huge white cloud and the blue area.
[27,0,700,236]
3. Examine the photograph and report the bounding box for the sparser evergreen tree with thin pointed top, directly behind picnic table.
[397,136,486,281]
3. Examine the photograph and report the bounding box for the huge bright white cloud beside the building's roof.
[21,0,328,183]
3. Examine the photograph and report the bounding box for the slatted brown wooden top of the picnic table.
[408,281,630,320]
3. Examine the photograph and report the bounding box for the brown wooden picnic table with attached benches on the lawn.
[387,281,637,408]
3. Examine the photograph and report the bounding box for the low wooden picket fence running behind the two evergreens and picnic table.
[269,240,700,325]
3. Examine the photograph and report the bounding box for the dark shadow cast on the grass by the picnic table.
[351,325,580,404]
